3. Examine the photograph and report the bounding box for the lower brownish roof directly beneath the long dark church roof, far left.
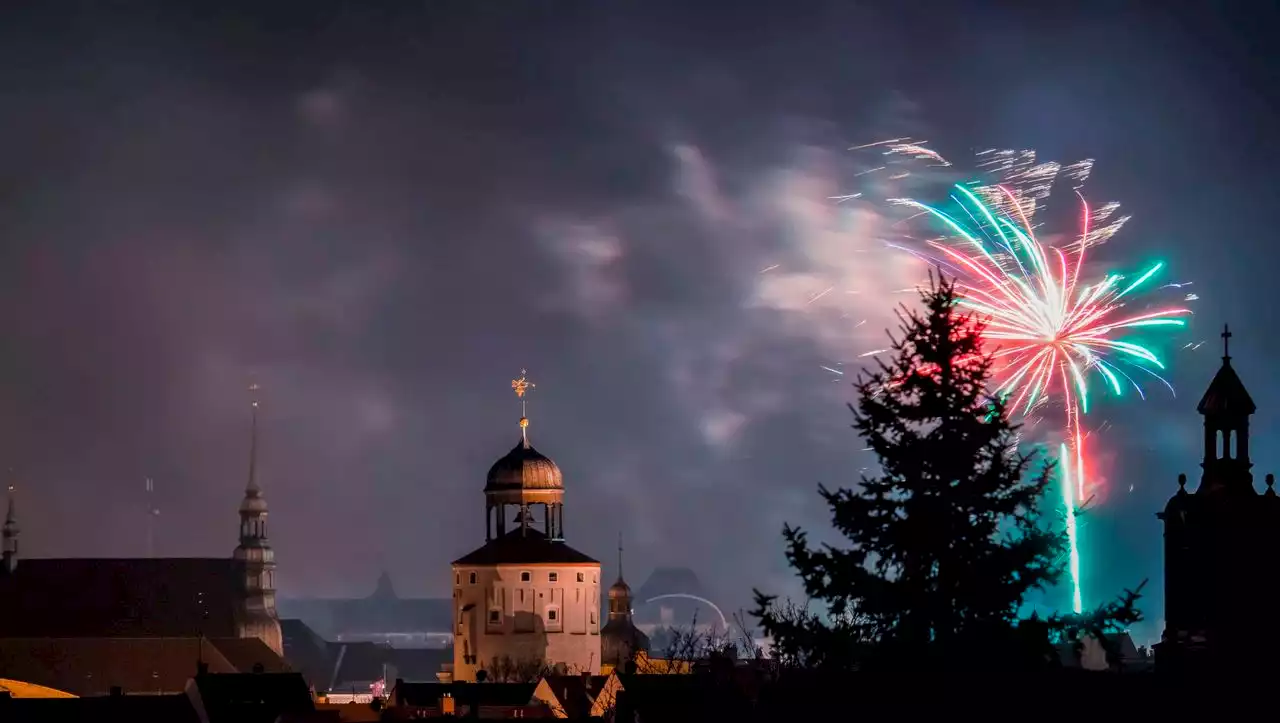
[0,637,236,696]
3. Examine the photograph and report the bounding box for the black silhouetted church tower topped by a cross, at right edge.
[1156,329,1280,673]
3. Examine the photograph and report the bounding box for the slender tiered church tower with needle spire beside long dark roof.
[234,384,284,655]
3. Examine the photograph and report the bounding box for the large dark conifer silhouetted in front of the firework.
[755,276,1137,668]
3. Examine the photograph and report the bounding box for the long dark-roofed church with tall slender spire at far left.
[0,386,283,655]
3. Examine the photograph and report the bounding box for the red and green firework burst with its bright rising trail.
[864,138,1194,613]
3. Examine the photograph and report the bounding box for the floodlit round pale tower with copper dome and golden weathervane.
[452,372,600,681]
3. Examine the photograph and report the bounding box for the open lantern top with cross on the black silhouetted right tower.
[1196,326,1257,491]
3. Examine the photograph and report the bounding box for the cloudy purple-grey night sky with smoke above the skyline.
[0,0,1280,636]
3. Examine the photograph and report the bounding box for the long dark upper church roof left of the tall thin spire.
[0,558,244,637]
